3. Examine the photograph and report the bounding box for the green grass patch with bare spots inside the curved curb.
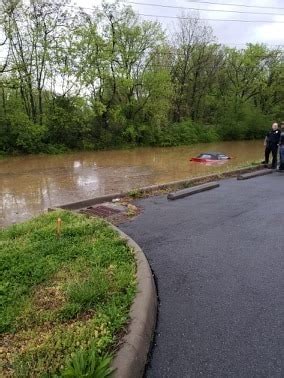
[0,211,136,377]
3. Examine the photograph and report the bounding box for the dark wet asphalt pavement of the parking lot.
[120,172,284,378]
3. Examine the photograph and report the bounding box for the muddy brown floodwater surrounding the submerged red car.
[0,141,263,227]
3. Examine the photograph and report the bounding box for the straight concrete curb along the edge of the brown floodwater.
[53,165,263,210]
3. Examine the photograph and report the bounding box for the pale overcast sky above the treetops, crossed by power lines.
[73,0,284,48]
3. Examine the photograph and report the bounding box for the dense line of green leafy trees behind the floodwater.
[0,0,284,152]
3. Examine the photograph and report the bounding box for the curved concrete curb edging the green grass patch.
[110,224,157,378]
